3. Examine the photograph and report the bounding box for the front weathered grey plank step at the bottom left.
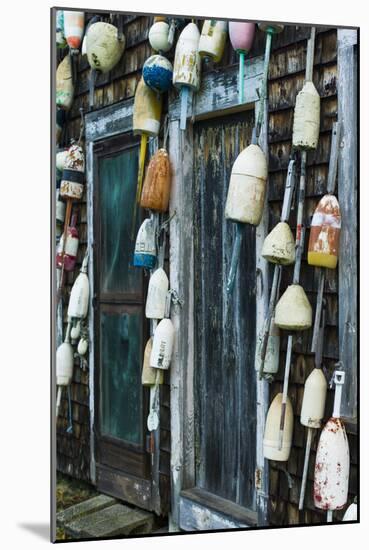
[64,504,154,539]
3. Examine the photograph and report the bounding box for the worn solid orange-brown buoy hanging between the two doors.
[140,149,171,212]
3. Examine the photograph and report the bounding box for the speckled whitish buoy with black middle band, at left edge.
[60,144,85,200]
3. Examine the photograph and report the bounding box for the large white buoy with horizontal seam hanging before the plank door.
[225,144,268,225]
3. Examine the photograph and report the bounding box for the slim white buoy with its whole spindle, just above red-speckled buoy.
[299,312,327,510]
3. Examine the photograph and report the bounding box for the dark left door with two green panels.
[94,136,151,509]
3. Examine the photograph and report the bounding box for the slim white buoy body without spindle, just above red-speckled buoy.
[300,368,327,429]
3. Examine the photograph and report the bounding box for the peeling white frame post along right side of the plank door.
[255,100,269,526]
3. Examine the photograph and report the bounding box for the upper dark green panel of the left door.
[99,147,142,294]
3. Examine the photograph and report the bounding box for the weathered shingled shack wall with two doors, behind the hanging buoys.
[55,8,358,530]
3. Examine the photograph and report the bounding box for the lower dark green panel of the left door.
[100,311,142,444]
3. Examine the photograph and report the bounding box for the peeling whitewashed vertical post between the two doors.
[169,120,195,531]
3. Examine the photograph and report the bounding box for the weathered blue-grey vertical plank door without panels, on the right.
[194,111,256,510]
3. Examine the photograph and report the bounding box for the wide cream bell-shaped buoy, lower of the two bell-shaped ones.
[275,284,313,330]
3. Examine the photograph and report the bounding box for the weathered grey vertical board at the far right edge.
[337,29,357,419]
